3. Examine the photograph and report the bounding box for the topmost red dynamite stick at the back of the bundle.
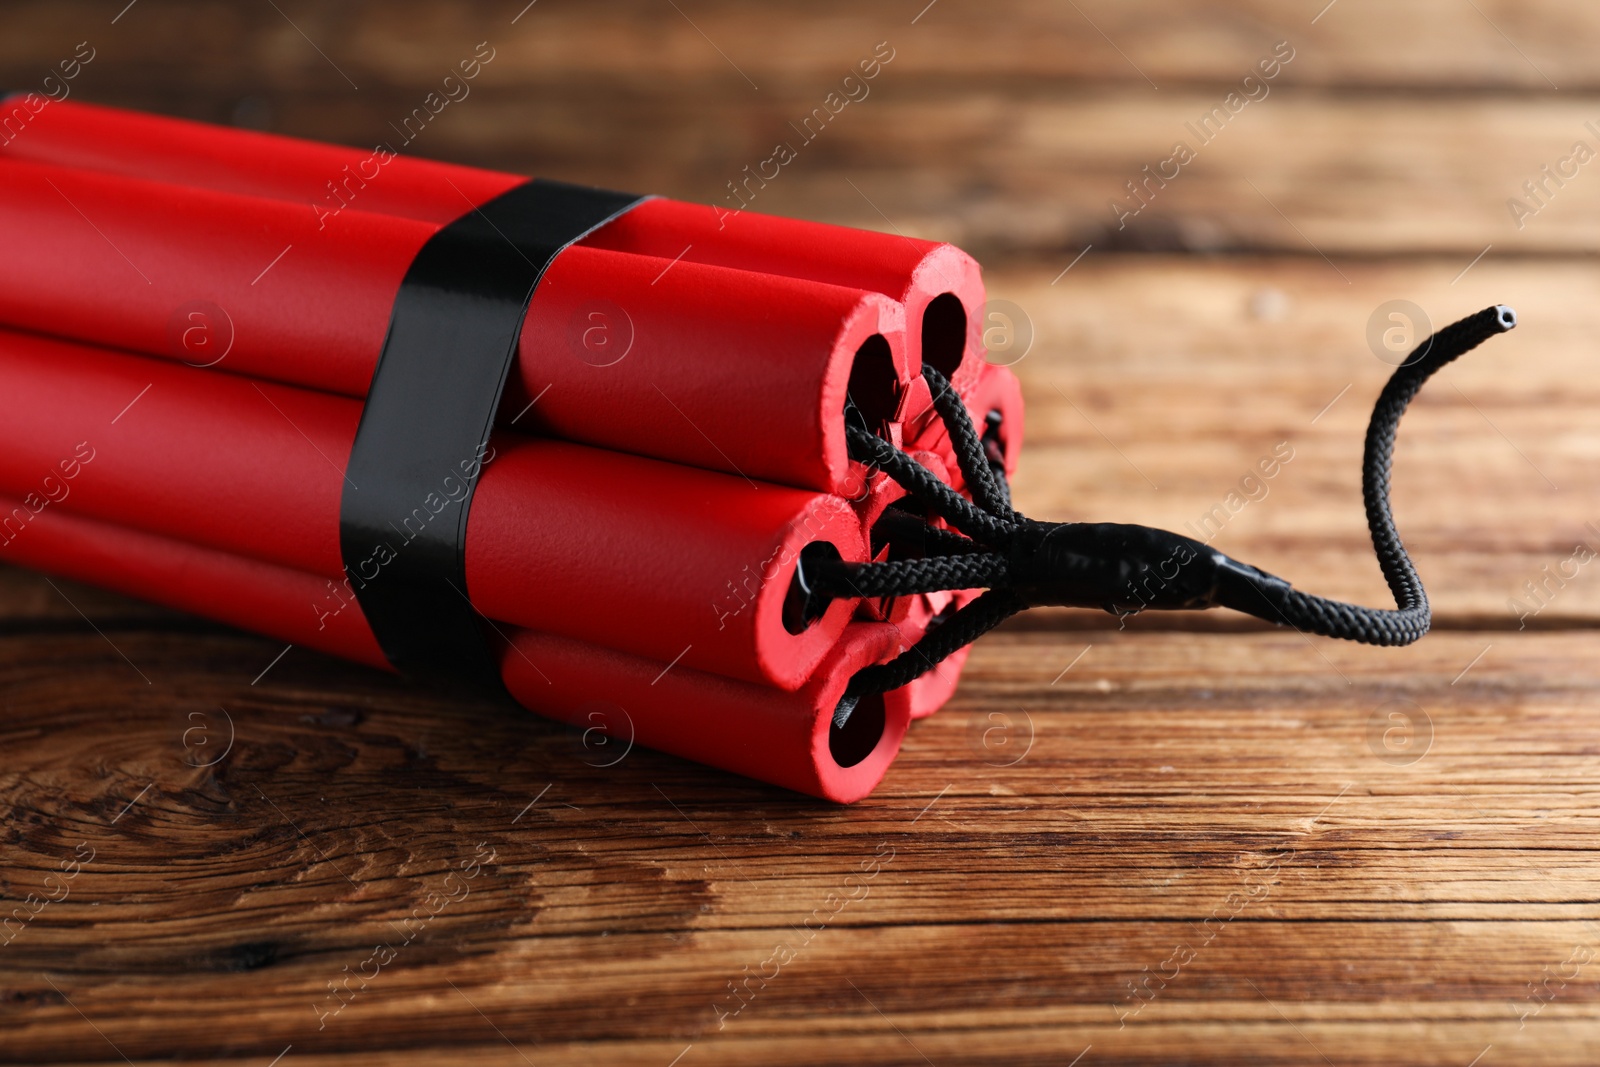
[0,98,984,389]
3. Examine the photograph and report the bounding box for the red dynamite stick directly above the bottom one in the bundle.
[0,333,866,689]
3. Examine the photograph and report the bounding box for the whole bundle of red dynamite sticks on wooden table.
[0,98,1022,801]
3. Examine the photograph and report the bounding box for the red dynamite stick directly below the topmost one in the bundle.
[0,162,920,491]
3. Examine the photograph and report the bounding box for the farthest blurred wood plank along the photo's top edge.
[0,0,1600,93]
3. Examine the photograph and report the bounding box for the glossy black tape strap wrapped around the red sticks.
[339,179,645,693]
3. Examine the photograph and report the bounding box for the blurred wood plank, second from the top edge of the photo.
[31,87,1600,255]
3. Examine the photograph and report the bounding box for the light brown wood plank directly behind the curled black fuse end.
[987,253,1600,620]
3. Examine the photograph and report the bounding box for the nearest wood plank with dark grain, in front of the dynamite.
[0,620,1600,1064]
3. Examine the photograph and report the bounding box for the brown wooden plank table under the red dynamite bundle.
[0,0,1600,1067]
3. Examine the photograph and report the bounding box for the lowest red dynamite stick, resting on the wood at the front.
[0,498,909,803]
